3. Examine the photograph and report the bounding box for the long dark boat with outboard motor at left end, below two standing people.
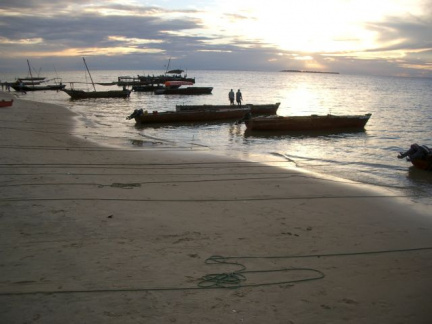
[126,108,250,124]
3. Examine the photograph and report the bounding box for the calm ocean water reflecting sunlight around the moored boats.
[1,70,432,209]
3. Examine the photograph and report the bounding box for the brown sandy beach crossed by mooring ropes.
[0,93,432,324]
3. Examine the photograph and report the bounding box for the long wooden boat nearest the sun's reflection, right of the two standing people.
[244,114,371,131]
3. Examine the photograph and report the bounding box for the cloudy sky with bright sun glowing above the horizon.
[0,0,432,77]
